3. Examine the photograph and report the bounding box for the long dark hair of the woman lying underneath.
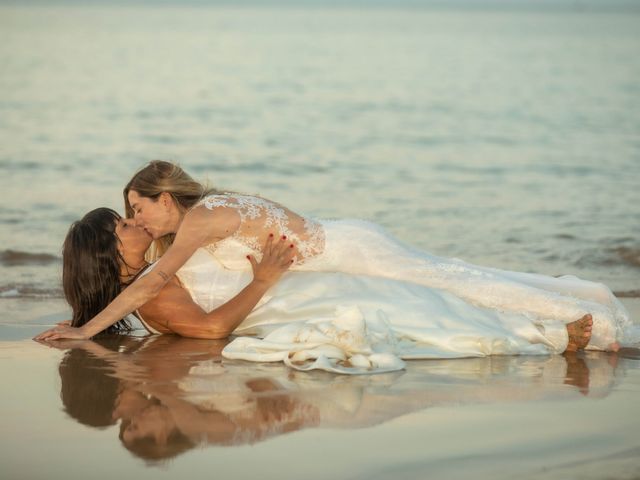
[62,208,132,333]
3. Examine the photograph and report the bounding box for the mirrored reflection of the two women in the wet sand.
[57,335,628,461]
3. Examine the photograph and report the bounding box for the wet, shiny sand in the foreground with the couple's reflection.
[0,299,640,480]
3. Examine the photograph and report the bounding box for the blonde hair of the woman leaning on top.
[122,160,221,261]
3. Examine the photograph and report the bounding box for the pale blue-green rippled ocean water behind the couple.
[0,2,640,304]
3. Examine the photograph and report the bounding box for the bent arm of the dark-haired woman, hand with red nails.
[140,238,293,339]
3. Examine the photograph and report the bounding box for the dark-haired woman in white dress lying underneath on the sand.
[46,208,592,373]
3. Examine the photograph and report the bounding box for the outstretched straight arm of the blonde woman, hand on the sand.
[36,207,240,340]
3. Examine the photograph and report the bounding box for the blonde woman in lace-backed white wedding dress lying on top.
[38,161,633,356]
